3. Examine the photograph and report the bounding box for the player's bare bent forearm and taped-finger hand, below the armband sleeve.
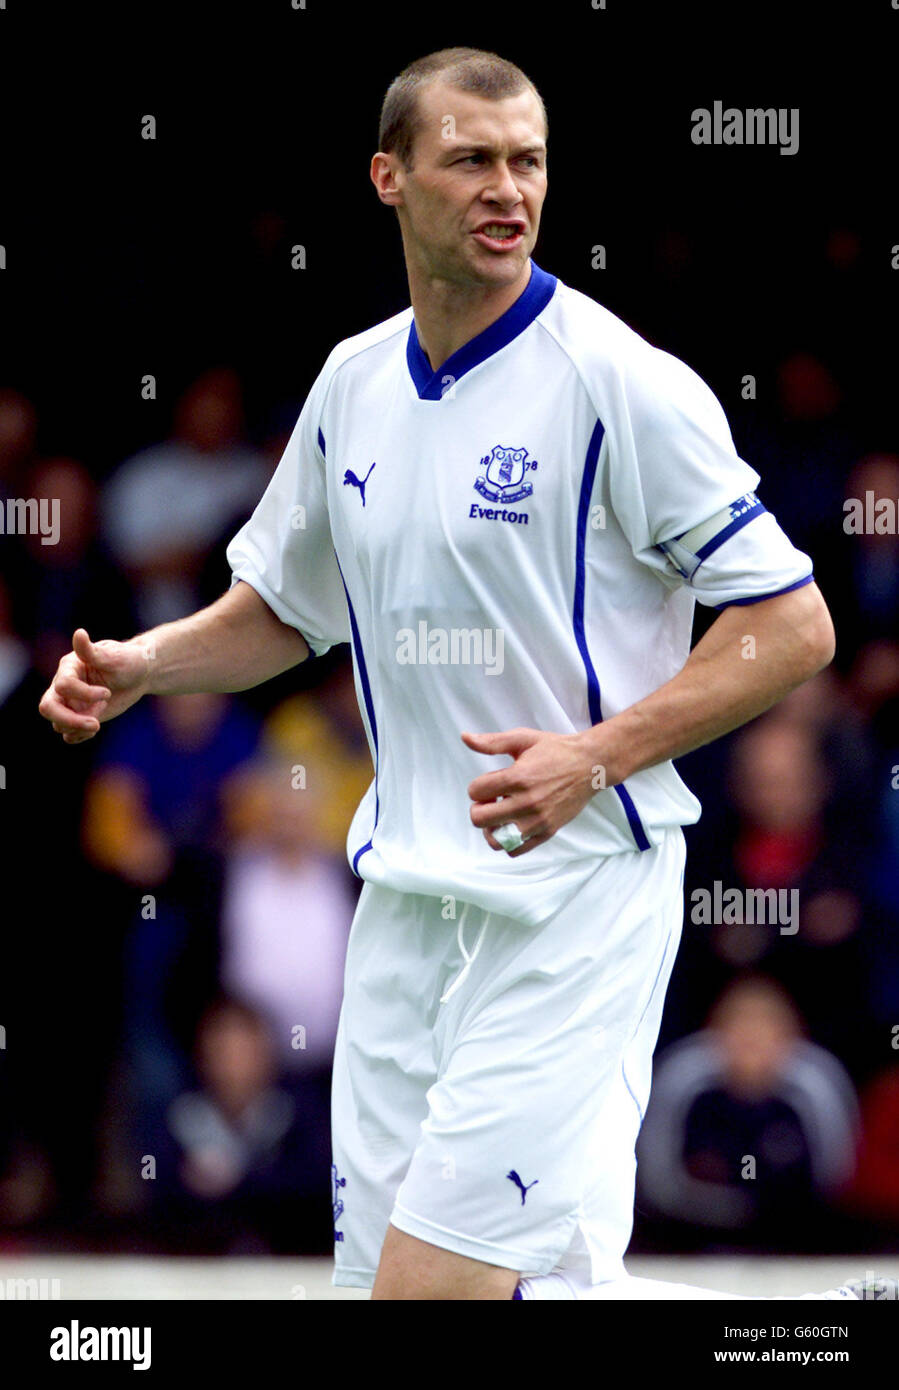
[461,584,834,858]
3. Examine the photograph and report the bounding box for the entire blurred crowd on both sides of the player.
[0,282,899,1252]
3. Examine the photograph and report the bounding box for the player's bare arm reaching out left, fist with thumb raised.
[39,581,310,744]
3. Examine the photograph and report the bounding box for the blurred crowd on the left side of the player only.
[0,368,372,1252]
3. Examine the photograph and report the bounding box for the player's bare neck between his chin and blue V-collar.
[407,260,531,371]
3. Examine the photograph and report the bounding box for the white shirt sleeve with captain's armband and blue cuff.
[609,345,813,607]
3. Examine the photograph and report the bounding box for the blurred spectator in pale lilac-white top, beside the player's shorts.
[221,763,356,1073]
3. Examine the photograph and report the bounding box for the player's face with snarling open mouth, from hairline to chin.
[386,81,546,285]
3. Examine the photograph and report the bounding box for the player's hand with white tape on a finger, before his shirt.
[461,728,597,859]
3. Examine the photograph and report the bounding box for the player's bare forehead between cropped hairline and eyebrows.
[415,79,546,152]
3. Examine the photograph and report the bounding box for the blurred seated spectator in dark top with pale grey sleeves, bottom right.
[638,977,857,1251]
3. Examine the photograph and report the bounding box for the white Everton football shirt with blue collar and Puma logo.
[228,261,813,924]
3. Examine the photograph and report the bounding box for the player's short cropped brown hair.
[378,49,549,171]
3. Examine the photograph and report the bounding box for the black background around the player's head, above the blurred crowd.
[0,0,898,471]
